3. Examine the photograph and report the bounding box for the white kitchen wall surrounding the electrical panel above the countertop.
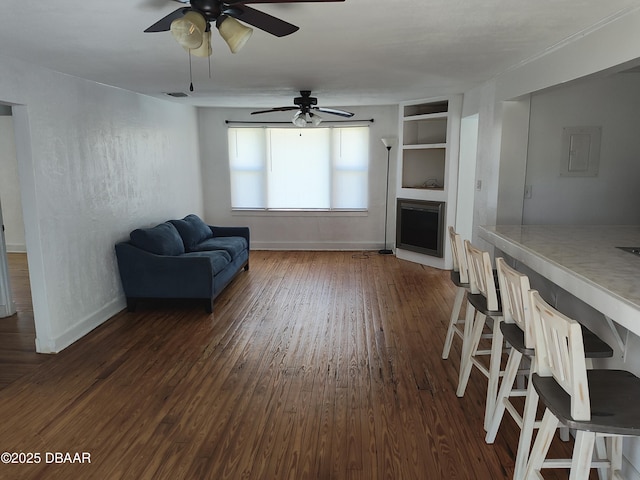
[522,73,640,225]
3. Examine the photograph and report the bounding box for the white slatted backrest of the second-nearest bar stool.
[496,258,535,348]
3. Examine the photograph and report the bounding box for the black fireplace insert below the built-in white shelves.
[396,198,445,258]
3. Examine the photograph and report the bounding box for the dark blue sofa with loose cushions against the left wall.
[115,215,249,313]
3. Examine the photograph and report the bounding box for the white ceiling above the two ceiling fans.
[0,0,638,107]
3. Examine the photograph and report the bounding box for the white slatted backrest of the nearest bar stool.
[529,290,591,421]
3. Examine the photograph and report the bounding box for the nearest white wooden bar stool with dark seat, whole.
[524,290,640,480]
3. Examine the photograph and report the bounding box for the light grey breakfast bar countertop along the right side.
[479,225,640,335]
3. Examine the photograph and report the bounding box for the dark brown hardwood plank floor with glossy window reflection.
[0,251,584,480]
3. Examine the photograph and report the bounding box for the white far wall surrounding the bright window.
[198,105,398,250]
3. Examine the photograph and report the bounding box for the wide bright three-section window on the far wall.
[229,127,369,210]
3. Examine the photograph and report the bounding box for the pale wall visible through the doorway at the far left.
[0,115,26,252]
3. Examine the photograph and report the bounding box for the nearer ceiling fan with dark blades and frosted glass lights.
[145,0,344,57]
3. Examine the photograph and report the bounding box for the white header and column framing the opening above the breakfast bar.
[463,9,640,247]
